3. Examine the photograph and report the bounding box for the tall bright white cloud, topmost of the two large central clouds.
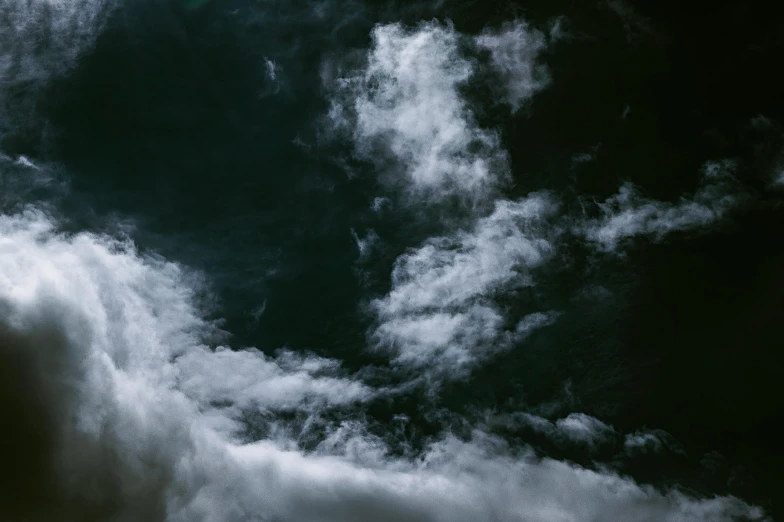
[330,23,508,199]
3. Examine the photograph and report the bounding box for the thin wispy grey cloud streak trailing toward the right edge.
[575,160,742,252]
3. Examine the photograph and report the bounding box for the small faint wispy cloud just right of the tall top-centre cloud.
[475,20,550,112]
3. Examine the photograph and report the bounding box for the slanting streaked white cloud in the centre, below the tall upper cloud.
[371,194,557,377]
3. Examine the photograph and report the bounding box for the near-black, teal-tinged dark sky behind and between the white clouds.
[0,0,784,520]
